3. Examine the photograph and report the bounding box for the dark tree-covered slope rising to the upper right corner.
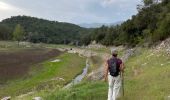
[84,0,170,46]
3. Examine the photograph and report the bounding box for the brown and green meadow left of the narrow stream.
[0,42,86,97]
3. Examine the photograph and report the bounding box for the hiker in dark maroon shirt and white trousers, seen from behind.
[105,50,124,100]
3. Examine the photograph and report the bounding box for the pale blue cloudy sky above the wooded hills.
[0,0,141,24]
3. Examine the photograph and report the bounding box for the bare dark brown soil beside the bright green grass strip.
[0,49,61,83]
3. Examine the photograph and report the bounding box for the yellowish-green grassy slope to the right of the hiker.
[121,50,170,100]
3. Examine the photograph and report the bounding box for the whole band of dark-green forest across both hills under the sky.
[0,0,170,46]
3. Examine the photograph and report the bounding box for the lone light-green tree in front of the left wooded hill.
[13,24,25,46]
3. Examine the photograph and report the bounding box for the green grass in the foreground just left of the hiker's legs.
[44,81,107,100]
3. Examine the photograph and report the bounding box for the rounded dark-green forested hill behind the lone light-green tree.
[0,16,90,44]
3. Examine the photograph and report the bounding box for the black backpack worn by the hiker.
[108,58,120,76]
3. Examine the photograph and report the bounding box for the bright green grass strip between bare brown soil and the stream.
[0,53,85,97]
